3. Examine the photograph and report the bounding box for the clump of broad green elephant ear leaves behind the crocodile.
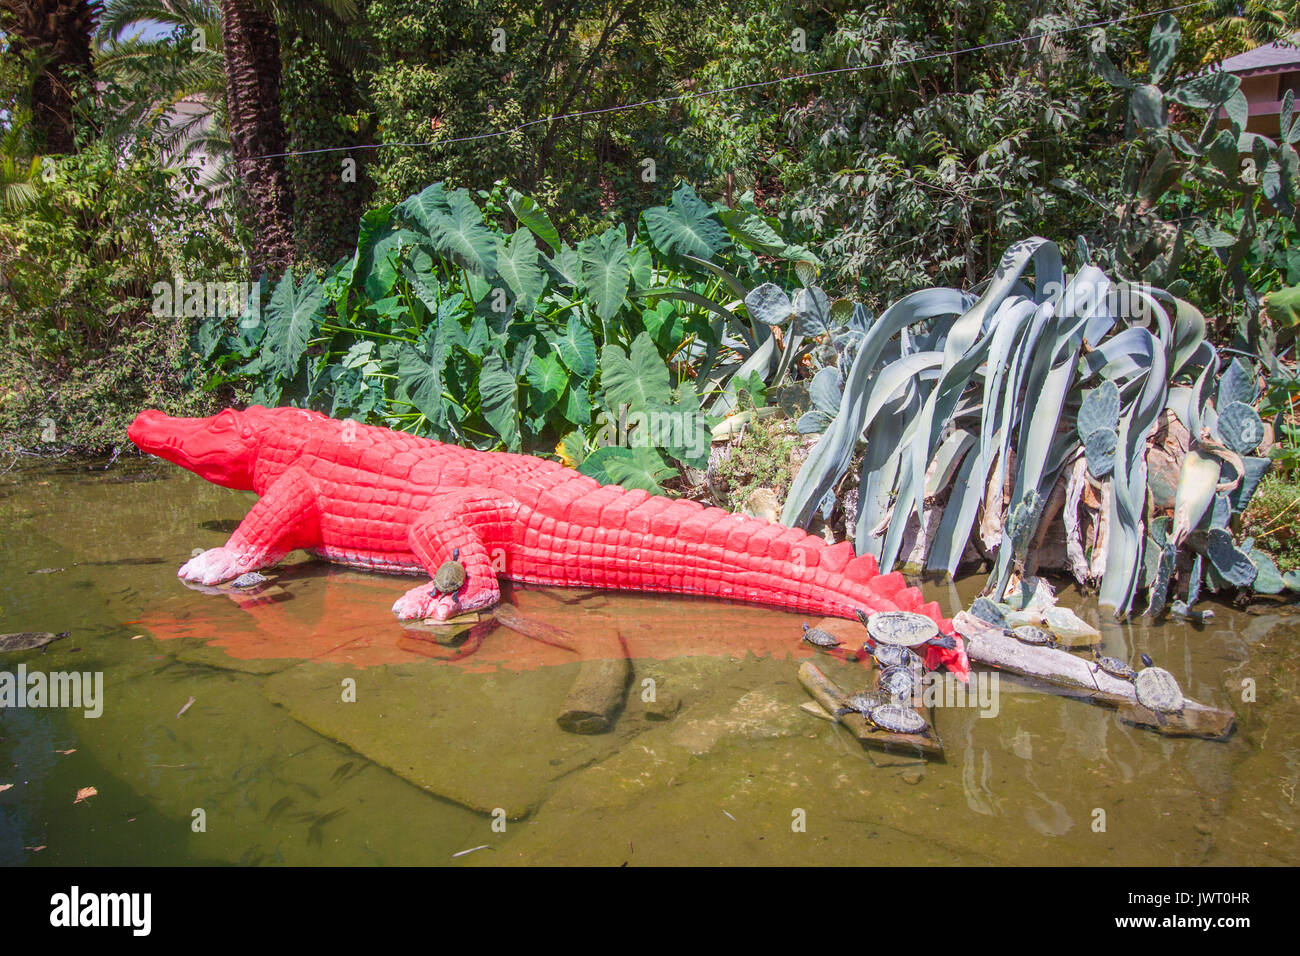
[195,183,829,493]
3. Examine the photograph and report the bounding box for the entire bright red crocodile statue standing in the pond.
[129,406,970,676]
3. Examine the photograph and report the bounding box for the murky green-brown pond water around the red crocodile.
[0,459,1300,866]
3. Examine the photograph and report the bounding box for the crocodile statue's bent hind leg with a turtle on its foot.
[393,490,512,620]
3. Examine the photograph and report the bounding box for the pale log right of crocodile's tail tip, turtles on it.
[953,611,1236,740]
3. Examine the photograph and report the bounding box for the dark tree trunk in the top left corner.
[0,0,100,153]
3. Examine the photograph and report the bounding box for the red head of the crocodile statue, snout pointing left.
[126,408,261,492]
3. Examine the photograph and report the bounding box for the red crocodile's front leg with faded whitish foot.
[177,468,316,584]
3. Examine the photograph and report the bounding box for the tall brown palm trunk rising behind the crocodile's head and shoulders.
[221,0,294,277]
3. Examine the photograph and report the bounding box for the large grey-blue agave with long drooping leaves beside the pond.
[781,238,1281,614]
